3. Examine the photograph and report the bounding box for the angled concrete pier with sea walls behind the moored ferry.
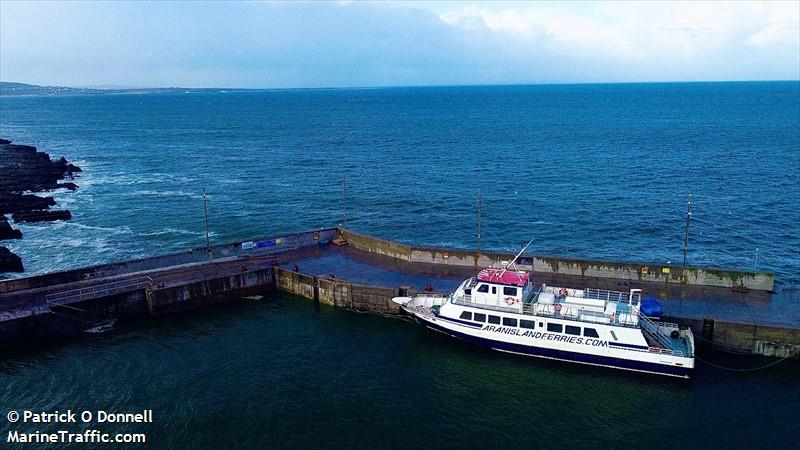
[0,228,800,358]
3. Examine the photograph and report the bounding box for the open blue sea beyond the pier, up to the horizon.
[0,82,800,284]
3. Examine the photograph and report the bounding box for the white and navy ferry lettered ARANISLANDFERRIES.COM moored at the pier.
[393,249,694,378]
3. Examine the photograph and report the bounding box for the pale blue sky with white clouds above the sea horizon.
[0,0,800,88]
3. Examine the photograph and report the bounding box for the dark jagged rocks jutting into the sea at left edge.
[0,139,81,274]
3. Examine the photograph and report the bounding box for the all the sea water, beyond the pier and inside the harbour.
[0,82,800,449]
